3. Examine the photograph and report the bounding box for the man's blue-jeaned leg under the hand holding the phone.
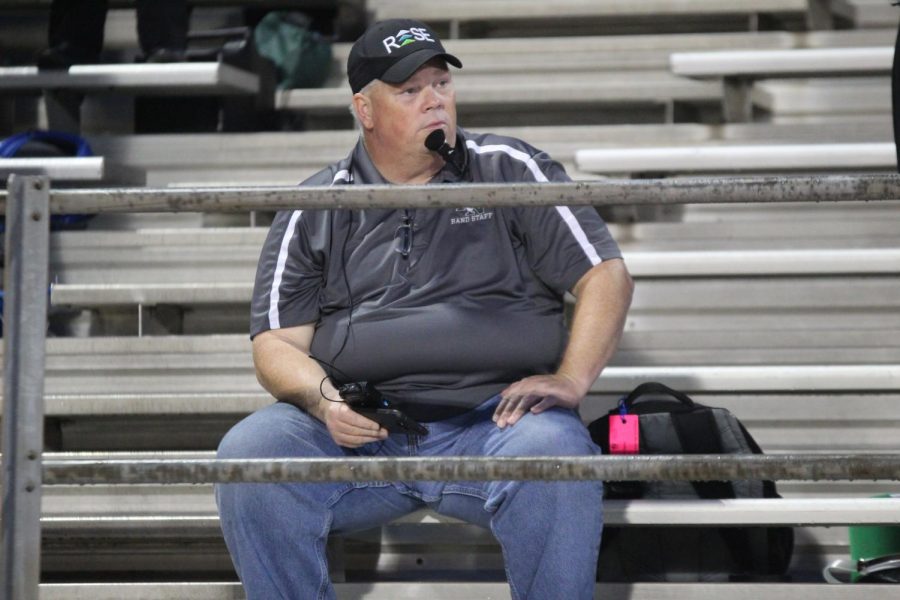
[216,403,422,600]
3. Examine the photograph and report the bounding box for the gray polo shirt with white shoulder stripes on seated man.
[251,129,621,421]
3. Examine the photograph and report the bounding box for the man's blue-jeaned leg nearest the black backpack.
[419,401,603,600]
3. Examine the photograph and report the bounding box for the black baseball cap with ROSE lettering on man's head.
[347,19,462,94]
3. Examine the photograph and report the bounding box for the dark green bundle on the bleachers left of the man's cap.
[253,10,331,89]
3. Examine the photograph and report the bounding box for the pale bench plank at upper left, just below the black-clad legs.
[0,62,259,95]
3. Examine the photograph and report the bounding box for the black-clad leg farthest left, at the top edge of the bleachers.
[38,0,107,69]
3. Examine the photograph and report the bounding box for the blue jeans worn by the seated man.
[216,398,603,600]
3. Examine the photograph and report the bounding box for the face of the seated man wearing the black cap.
[362,59,456,152]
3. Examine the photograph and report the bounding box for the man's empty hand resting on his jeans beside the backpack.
[494,373,586,429]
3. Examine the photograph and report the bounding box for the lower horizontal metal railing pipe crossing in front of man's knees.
[44,453,900,485]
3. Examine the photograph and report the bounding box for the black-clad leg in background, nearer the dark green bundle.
[137,0,191,62]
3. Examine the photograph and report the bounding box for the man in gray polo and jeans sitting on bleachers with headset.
[216,19,632,600]
